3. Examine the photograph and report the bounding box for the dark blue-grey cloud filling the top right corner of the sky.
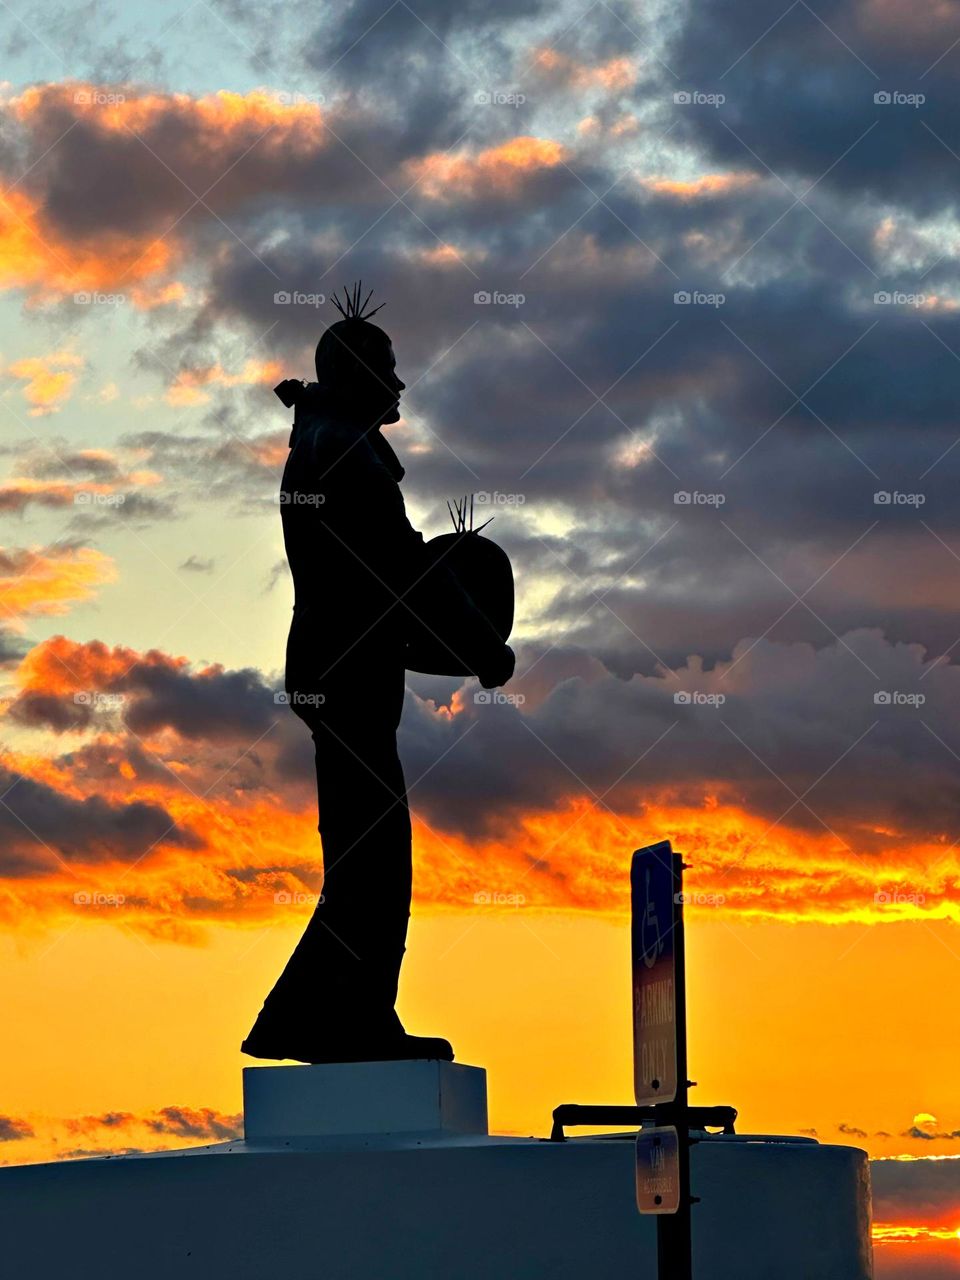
[669,0,960,214]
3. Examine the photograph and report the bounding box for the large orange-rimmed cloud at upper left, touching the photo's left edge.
[0,82,326,307]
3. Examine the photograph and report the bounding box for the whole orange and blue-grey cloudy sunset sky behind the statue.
[0,0,960,1280]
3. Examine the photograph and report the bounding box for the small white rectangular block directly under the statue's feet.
[243,1061,486,1142]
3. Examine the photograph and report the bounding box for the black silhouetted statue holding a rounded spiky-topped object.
[242,287,515,1062]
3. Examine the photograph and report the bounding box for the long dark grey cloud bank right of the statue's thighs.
[401,632,960,852]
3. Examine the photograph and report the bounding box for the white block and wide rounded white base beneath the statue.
[0,1062,873,1280]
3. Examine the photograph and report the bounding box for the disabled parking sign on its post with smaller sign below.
[630,840,692,1280]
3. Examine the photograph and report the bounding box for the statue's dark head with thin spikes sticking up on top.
[316,285,404,428]
